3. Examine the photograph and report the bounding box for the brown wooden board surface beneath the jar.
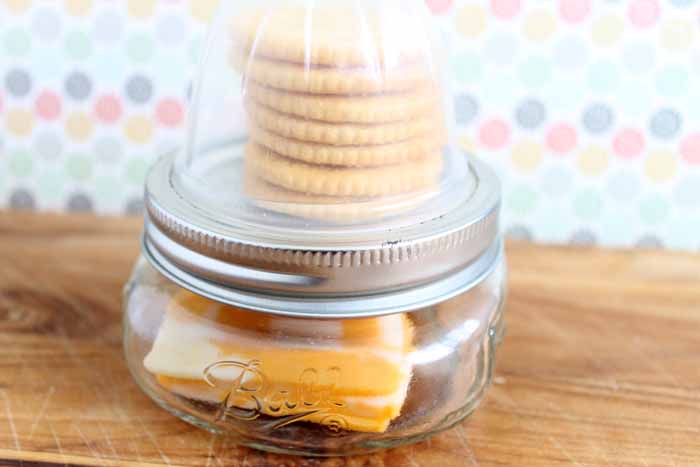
[0,213,700,467]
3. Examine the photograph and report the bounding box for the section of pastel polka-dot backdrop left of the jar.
[0,0,198,214]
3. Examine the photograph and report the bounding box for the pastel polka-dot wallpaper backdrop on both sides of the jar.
[0,0,700,250]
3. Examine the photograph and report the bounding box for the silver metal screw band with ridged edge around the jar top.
[142,153,501,316]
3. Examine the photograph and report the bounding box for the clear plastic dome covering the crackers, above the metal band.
[173,0,475,235]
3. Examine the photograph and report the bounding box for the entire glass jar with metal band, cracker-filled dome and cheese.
[124,0,506,455]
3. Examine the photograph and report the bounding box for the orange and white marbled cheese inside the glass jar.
[144,291,413,432]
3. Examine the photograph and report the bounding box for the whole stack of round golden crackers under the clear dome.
[231,7,445,218]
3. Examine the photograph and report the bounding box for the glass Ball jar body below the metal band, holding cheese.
[124,259,506,456]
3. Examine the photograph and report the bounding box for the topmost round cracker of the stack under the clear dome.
[231,2,431,68]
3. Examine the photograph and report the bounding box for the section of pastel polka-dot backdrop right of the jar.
[448,0,700,250]
